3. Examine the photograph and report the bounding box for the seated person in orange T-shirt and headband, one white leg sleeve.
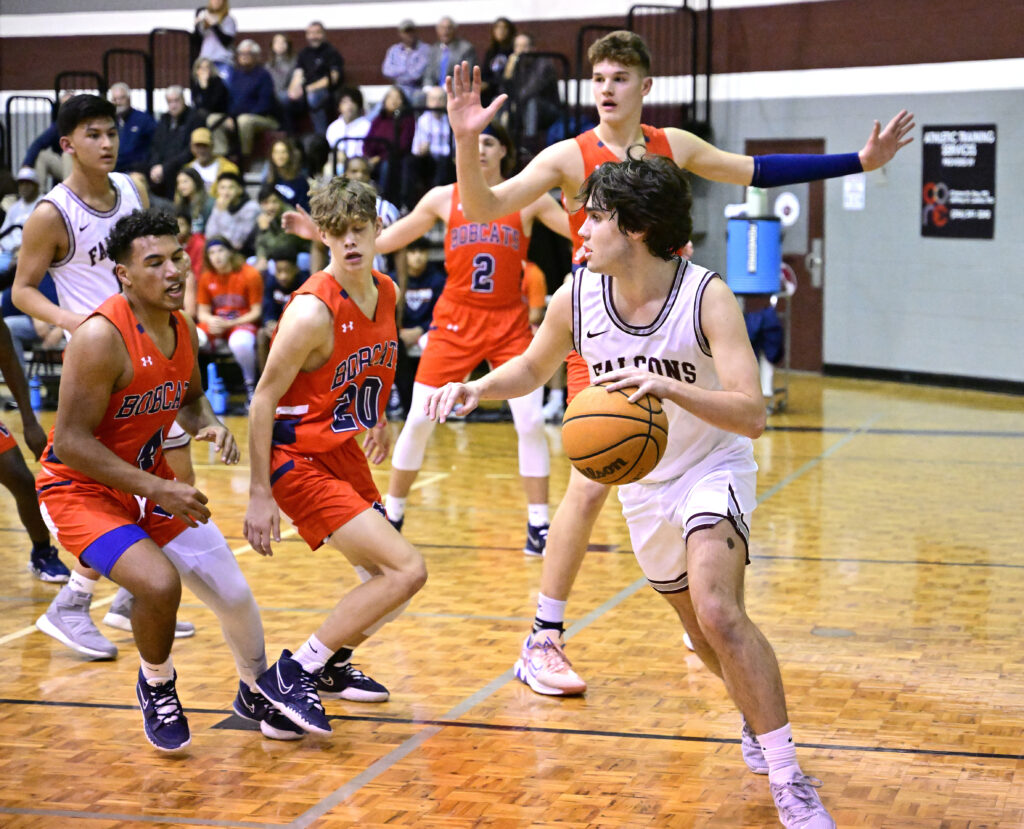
[196,235,263,397]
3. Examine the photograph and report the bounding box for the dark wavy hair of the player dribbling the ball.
[577,146,693,260]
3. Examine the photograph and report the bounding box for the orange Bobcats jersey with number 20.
[273,270,398,454]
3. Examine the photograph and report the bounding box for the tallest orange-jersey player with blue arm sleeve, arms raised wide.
[447,31,913,695]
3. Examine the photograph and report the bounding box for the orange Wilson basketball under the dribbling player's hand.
[562,385,669,485]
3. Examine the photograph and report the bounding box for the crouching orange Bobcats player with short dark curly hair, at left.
[37,210,302,751]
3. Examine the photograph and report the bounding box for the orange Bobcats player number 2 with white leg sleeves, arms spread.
[368,119,568,556]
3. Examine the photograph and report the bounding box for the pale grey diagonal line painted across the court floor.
[288,412,883,829]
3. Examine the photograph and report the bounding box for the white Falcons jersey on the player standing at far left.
[43,173,142,314]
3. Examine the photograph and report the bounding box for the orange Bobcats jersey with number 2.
[442,184,529,308]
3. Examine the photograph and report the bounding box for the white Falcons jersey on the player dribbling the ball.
[572,254,754,483]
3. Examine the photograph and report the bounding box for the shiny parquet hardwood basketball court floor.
[0,377,1024,829]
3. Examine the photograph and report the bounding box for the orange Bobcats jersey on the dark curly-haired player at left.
[43,294,196,481]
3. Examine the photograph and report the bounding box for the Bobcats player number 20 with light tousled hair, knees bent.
[245,177,427,734]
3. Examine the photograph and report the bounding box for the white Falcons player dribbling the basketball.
[427,156,836,829]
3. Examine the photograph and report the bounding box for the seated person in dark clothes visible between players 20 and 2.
[394,236,445,411]
